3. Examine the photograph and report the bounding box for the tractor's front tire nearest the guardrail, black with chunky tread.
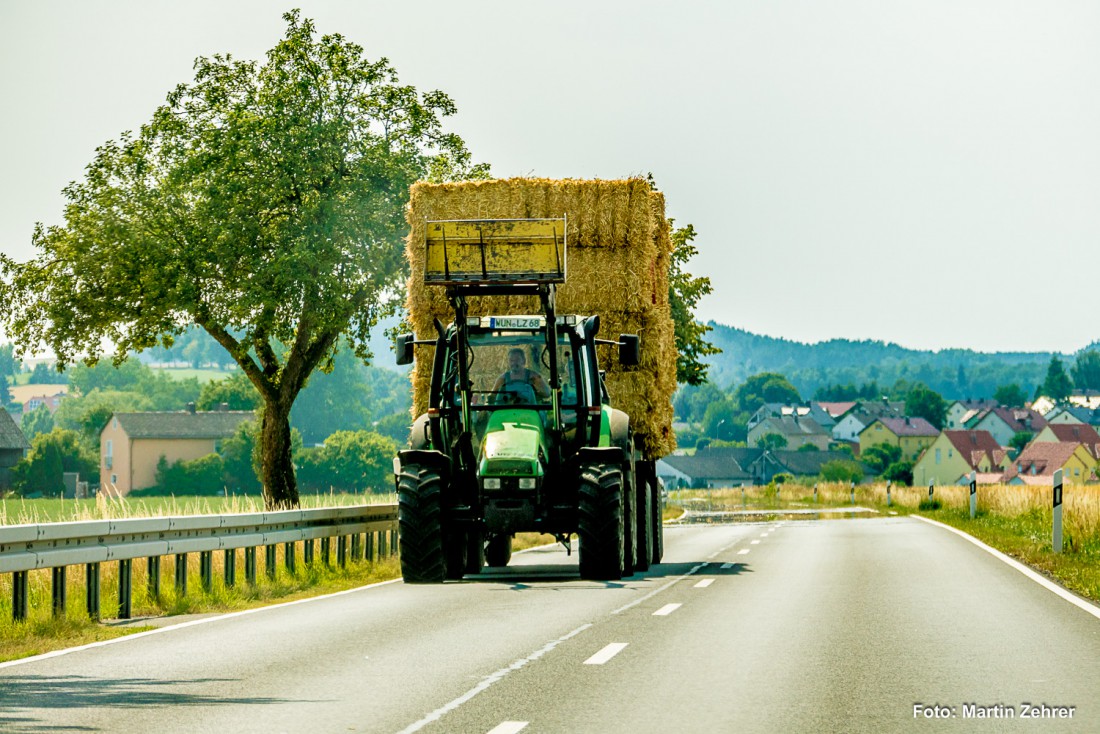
[397,464,447,583]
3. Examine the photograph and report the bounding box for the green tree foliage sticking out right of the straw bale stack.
[669,219,721,385]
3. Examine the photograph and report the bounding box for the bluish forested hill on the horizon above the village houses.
[707,321,1100,399]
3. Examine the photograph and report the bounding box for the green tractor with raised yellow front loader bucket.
[394,218,662,583]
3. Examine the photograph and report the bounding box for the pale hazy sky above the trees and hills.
[0,0,1100,352]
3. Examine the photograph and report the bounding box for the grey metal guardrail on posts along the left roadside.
[0,504,397,620]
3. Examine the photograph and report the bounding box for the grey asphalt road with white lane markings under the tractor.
[0,517,1100,734]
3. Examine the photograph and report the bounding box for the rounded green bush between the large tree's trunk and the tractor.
[298,430,397,492]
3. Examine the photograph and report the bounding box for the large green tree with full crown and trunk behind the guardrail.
[0,11,485,508]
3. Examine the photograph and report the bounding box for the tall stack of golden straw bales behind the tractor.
[406,178,677,459]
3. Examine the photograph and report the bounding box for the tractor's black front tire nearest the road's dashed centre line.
[576,464,625,581]
